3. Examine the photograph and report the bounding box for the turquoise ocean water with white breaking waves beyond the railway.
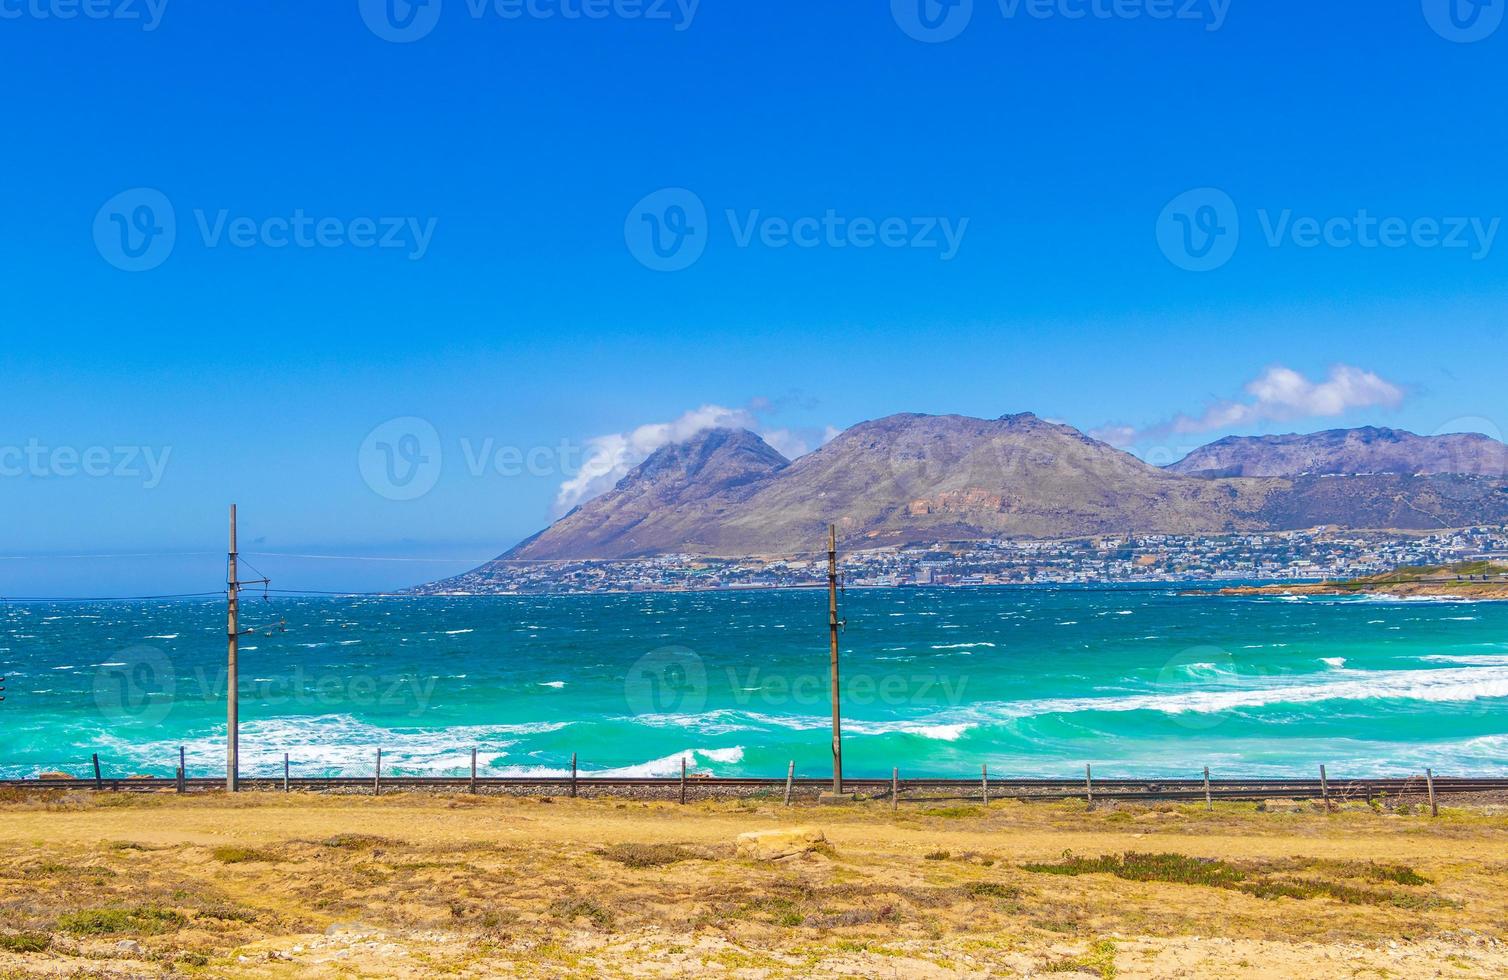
[0,586,1508,778]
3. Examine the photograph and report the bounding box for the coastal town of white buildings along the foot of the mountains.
[415,525,1508,596]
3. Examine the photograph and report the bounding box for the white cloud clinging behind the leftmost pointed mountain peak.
[555,398,834,514]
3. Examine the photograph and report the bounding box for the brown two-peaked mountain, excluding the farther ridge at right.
[507,415,1286,559]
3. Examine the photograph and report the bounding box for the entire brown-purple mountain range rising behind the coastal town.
[464,413,1508,559]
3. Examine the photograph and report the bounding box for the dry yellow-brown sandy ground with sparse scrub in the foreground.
[0,793,1508,977]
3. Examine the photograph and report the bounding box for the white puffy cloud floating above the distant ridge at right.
[1090,365,1405,448]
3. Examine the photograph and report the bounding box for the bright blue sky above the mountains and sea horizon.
[0,0,1508,596]
